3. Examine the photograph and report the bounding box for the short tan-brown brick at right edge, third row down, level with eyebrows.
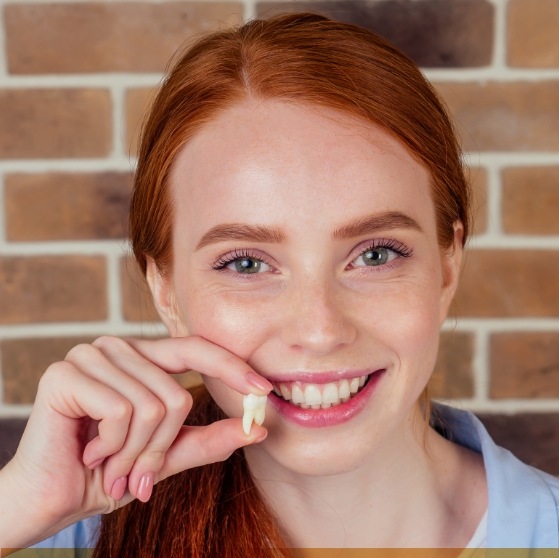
[502,167,559,234]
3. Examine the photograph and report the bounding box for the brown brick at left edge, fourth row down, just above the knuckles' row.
[0,256,107,324]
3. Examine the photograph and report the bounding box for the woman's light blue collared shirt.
[29,405,559,548]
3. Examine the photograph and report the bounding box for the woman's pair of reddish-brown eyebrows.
[196,211,422,250]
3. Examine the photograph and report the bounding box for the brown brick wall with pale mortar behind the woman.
[0,0,559,473]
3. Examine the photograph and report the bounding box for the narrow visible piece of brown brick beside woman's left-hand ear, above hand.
[120,257,159,322]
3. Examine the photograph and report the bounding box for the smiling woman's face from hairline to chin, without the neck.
[150,101,461,475]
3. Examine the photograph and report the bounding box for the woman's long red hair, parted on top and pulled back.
[95,10,470,558]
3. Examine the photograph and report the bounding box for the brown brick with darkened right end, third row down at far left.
[5,172,132,241]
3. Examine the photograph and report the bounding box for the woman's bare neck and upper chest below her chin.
[246,410,484,548]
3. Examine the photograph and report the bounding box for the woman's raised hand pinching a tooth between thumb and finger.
[0,337,272,547]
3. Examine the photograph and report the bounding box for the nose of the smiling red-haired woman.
[283,281,357,355]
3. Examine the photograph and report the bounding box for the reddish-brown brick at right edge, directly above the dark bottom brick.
[490,332,559,399]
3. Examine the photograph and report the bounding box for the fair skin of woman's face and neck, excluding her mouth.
[148,100,485,547]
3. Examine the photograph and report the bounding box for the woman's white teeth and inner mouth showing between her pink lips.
[274,374,372,409]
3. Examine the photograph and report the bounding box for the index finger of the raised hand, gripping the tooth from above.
[126,335,273,395]
